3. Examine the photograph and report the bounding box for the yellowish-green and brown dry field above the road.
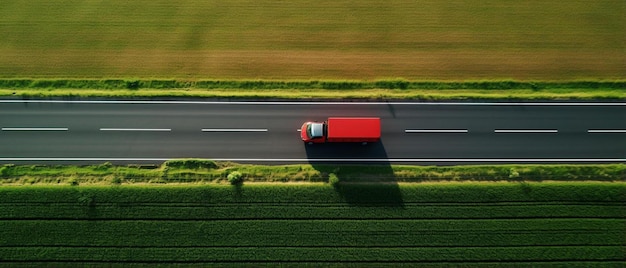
[0,0,626,80]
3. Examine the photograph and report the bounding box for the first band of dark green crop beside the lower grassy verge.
[0,182,626,202]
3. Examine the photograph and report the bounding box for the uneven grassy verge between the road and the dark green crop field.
[0,159,626,184]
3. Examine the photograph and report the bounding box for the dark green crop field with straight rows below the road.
[0,182,626,267]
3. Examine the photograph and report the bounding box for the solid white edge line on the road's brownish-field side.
[0,100,626,106]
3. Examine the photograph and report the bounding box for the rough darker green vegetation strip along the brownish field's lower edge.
[0,78,626,90]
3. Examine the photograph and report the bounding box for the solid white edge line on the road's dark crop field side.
[0,157,626,163]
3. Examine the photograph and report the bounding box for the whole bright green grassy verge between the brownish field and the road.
[0,79,626,100]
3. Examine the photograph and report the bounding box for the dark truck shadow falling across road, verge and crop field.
[304,141,404,207]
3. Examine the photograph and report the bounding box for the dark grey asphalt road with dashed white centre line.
[0,100,626,164]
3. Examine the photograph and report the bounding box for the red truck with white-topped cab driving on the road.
[300,117,380,144]
